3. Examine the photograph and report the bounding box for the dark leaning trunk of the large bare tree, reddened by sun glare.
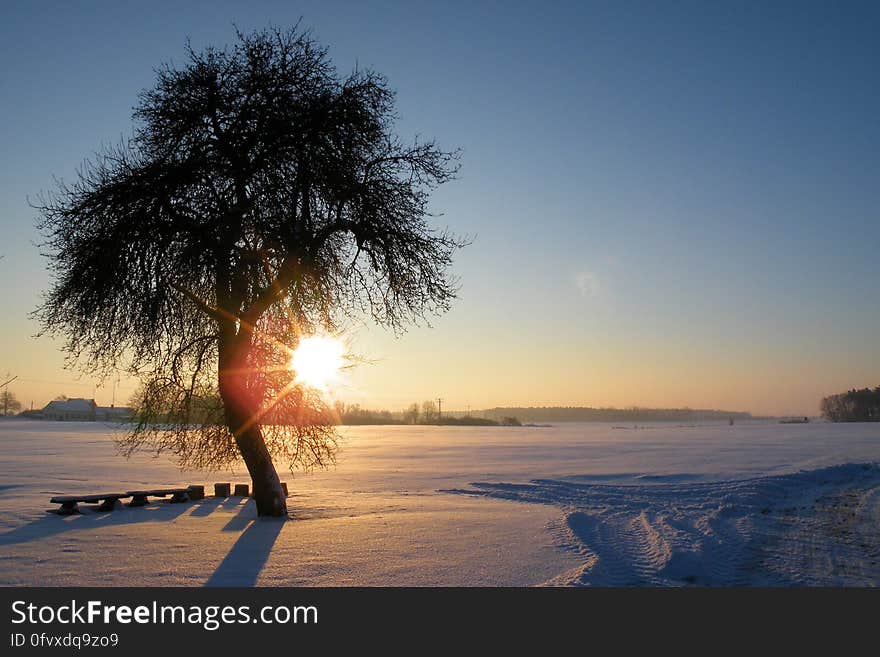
[219,338,287,517]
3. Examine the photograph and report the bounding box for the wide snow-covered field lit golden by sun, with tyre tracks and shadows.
[0,420,880,586]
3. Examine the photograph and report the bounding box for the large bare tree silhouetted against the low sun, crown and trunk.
[35,26,463,515]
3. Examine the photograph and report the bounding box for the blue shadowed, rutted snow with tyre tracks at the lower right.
[443,463,880,586]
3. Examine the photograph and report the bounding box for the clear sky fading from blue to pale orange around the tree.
[0,0,880,414]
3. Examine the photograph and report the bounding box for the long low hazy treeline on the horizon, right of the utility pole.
[476,406,752,422]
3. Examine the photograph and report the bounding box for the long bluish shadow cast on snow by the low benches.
[0,502,201,545]
